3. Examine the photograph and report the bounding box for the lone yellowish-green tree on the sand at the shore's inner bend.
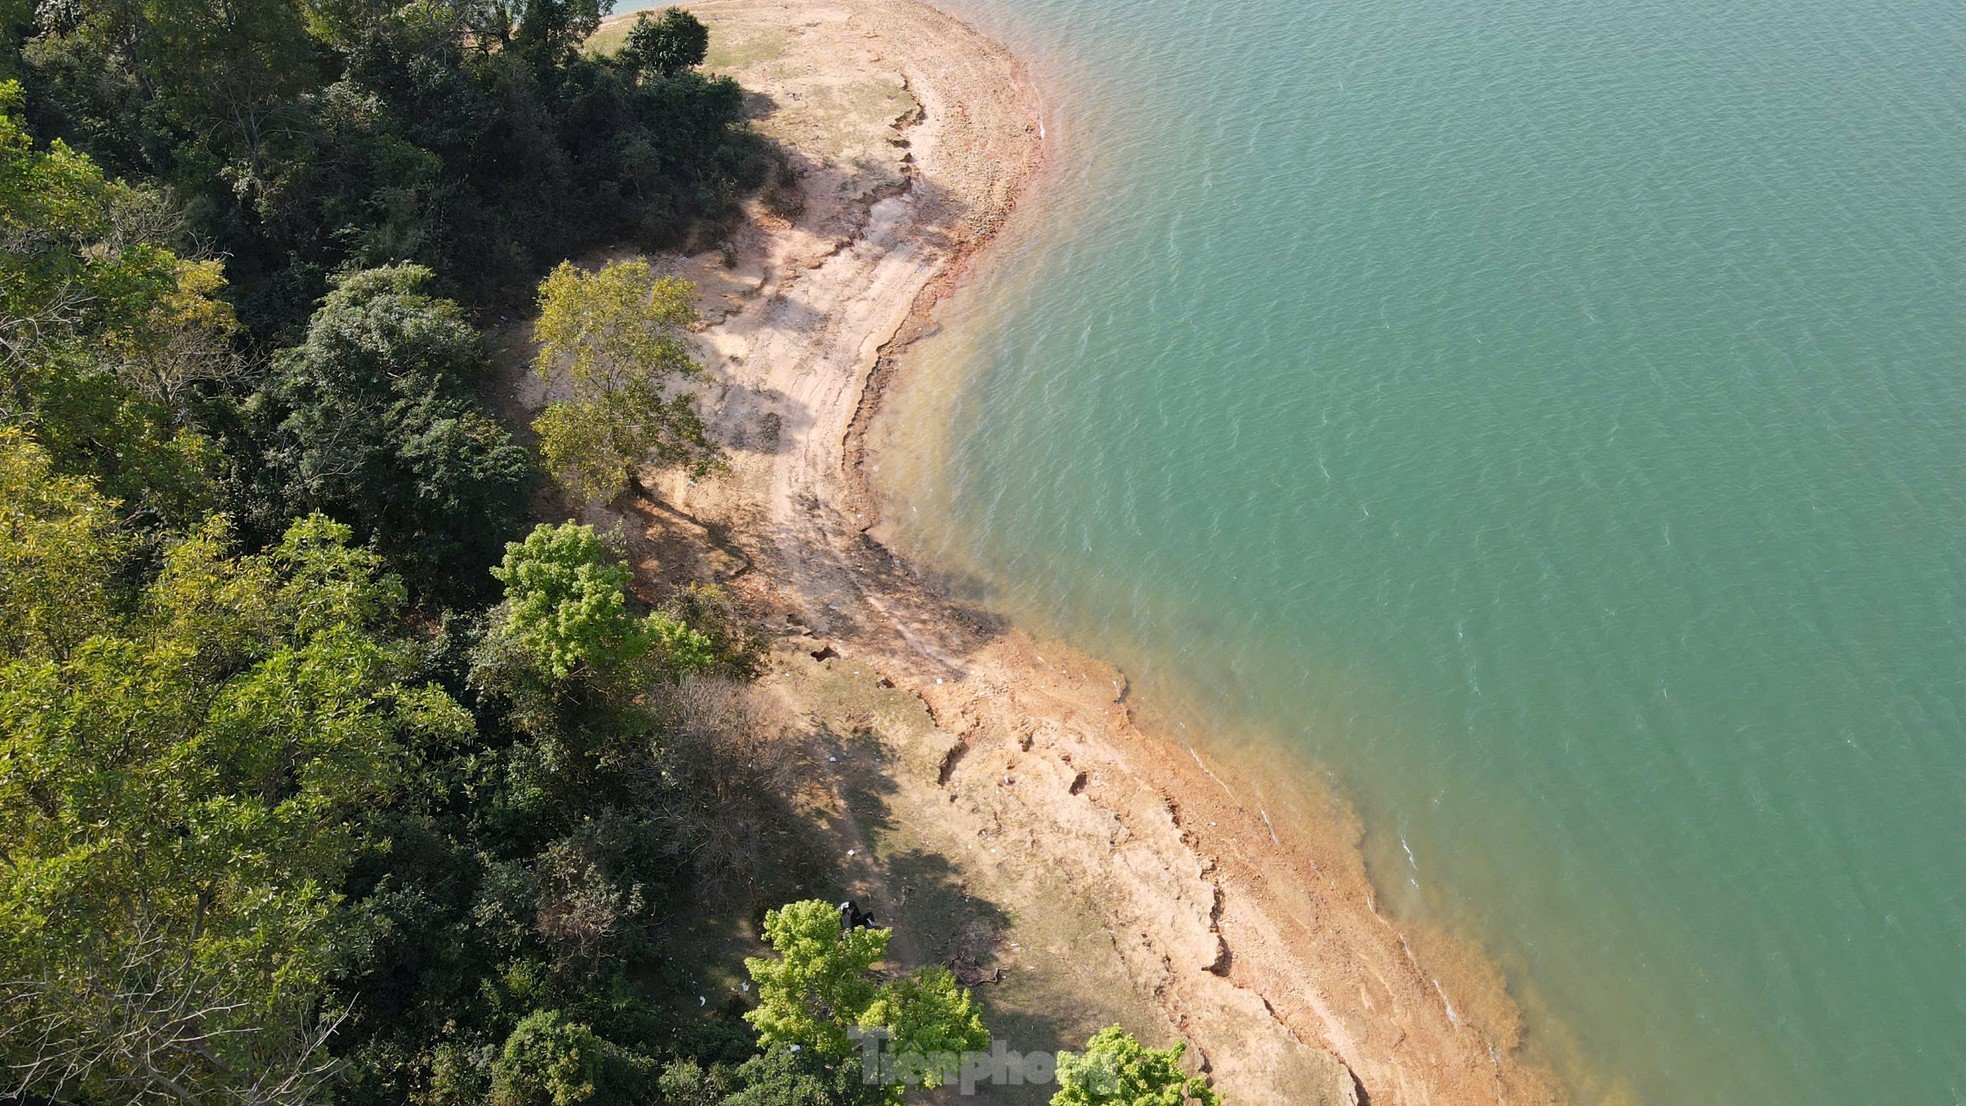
[533,261,722,499]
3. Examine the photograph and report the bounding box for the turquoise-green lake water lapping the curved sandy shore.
[888,0,1966,1106]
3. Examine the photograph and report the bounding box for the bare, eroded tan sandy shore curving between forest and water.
[570,0,1559,1106]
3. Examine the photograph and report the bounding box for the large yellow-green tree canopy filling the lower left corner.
[0,493,470,1102]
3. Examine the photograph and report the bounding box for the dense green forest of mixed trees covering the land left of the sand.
[0,0,1205,1106]
